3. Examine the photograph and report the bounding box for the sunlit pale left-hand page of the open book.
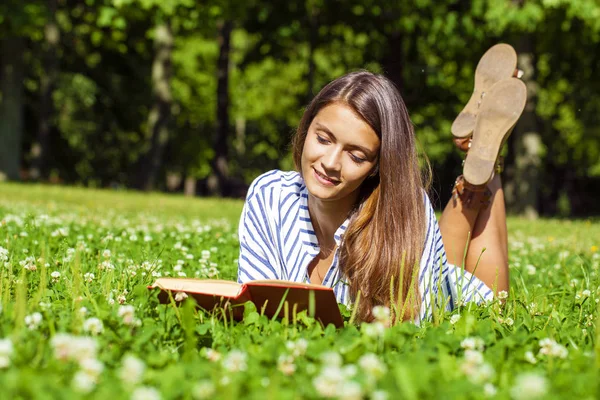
[152,278,242,297]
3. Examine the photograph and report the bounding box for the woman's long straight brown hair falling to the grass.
[292,71,427,321]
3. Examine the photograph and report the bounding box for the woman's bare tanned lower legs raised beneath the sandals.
[440,175,508,293]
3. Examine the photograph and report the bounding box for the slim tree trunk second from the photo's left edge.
[30,0,60,180]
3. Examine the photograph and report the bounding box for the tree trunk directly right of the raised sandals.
[505,35,542,219]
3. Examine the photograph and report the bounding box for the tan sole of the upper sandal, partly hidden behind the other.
[450,43,517,138]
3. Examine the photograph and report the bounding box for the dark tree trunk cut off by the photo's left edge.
[0,37,25,180]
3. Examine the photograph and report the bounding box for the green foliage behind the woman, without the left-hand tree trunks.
[0,0,600,212]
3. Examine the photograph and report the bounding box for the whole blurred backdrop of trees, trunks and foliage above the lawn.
[0,0,600,217]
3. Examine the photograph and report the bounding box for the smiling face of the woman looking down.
[302,103,380,201]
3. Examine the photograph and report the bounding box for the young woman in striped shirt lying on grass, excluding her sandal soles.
[238,63,520,321]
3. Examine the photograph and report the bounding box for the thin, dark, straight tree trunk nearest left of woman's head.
[207,21,233,196]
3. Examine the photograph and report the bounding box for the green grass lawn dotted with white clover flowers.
[0,184,600,399]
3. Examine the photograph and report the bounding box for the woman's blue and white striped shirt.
[238,170,493,322]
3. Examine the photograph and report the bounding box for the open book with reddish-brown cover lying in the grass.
[148,278,344,327]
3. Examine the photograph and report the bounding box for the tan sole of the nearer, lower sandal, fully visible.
[463,78,527,185]
